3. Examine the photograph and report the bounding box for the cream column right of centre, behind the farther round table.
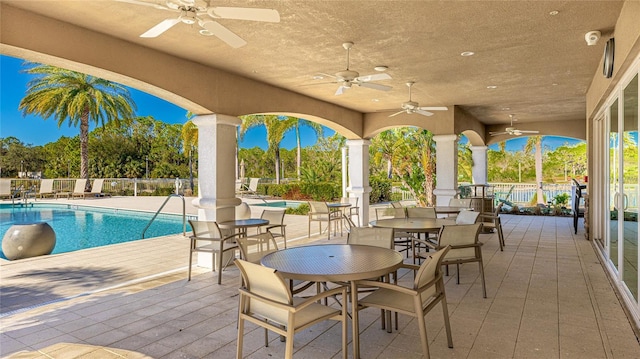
[433,135,458,206]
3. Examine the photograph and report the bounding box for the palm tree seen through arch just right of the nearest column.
[240,115,298,183]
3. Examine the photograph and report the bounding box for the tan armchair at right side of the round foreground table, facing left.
[358,247,453,358]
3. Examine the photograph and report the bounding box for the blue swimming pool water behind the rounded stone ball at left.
[0,204,191,259]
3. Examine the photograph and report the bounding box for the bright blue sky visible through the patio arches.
[0,55,581,151]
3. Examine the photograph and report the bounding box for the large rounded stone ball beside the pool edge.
[2,222,56,260]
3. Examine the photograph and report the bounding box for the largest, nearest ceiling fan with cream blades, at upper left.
[116,0,280,48]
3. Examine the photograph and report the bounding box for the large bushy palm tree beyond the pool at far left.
[18,64,136,184]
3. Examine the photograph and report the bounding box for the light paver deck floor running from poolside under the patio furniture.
[0,197,640,358]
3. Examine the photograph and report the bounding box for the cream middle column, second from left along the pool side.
[347,140,371,226]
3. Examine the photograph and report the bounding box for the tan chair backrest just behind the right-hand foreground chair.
[438,223,482,259]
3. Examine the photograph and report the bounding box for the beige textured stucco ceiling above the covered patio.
[2,0,622,129]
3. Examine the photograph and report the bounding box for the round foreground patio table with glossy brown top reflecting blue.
[261,244,402,358]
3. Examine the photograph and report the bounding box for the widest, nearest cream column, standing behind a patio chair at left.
[192,114,242,268]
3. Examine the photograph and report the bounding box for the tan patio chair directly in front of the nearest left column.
[187,219,238,284]
